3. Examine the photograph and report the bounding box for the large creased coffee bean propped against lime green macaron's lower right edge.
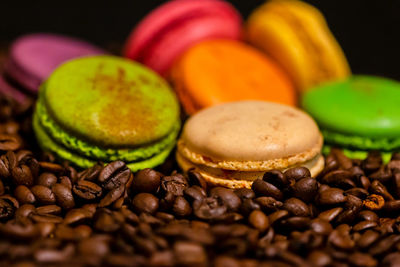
[98,161,131,190]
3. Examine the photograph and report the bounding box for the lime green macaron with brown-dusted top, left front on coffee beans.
[33,56,180,171]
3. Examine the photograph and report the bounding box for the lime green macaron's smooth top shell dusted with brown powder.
[41,56,179,147]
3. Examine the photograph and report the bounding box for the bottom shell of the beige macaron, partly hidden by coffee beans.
[176,152,325,188]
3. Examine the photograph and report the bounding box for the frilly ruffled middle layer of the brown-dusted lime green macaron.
[36,98,180,162]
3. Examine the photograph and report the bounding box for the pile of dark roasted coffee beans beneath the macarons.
[0,98,400,267]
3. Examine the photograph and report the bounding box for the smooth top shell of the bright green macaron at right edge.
[302,76,400,138]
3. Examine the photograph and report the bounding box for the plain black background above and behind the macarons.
[0,0,400,80]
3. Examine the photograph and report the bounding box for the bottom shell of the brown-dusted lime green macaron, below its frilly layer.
[33,113,175,172]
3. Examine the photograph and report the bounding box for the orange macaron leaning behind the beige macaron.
[169,40,296,114]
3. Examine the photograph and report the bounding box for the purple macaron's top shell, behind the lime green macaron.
[6,33,105,92]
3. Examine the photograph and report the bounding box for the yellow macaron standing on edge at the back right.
[245,0,350,92]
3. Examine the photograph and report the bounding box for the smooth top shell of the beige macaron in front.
[181,101,322,161]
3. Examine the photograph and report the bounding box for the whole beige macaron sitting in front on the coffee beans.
[176,101,324,188]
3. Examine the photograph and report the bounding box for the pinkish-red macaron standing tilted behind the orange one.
[124,0,242,76]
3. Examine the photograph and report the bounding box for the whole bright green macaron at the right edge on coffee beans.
[302,76,400,160]
